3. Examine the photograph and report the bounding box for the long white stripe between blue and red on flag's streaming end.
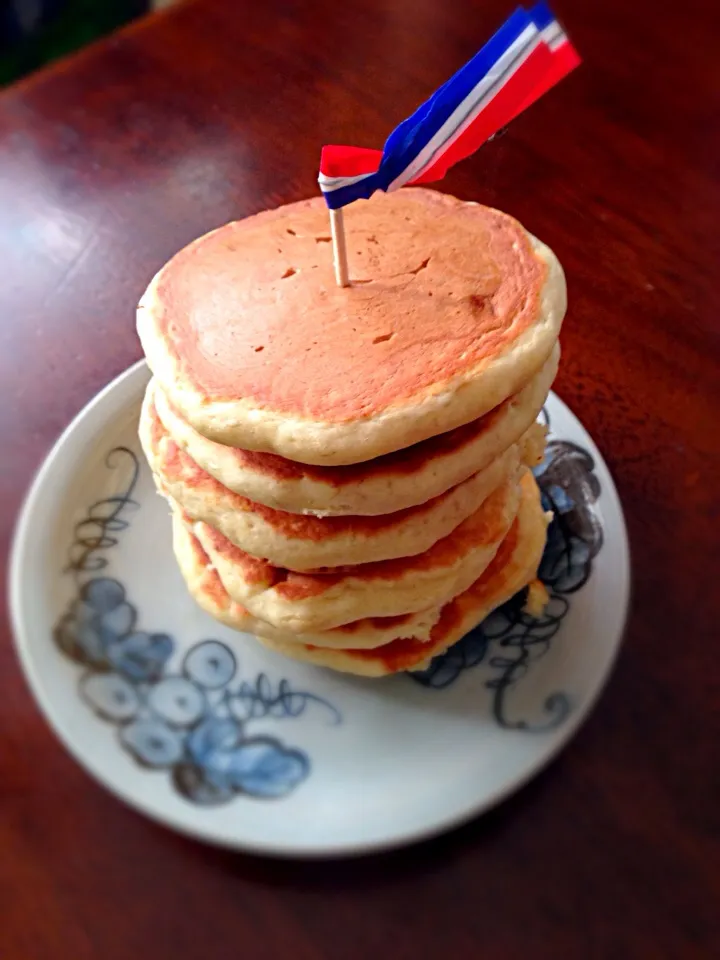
[388,24,542,193]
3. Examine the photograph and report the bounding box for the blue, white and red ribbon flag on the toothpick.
[318,3,580,210]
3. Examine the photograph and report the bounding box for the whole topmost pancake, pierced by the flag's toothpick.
[138,188,566,465]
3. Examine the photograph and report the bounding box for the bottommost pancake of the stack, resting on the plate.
[257,473,549,677]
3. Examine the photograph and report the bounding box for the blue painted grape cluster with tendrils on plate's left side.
[55,447,341,805]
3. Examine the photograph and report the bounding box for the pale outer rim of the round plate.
[7,359,632,860]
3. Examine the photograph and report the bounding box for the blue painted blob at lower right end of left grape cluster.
[228,737,310,798]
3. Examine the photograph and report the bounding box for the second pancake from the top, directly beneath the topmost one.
[149,345,560,516]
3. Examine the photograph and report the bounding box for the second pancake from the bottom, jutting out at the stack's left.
[173,512,441,649]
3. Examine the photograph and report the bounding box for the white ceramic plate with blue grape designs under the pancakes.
[11,363,629,856]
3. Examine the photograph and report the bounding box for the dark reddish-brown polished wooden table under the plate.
[0,0,720,960]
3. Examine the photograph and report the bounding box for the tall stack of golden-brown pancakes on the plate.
[138,189,565,676]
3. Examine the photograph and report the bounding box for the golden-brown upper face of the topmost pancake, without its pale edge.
[154,189,546,423]
